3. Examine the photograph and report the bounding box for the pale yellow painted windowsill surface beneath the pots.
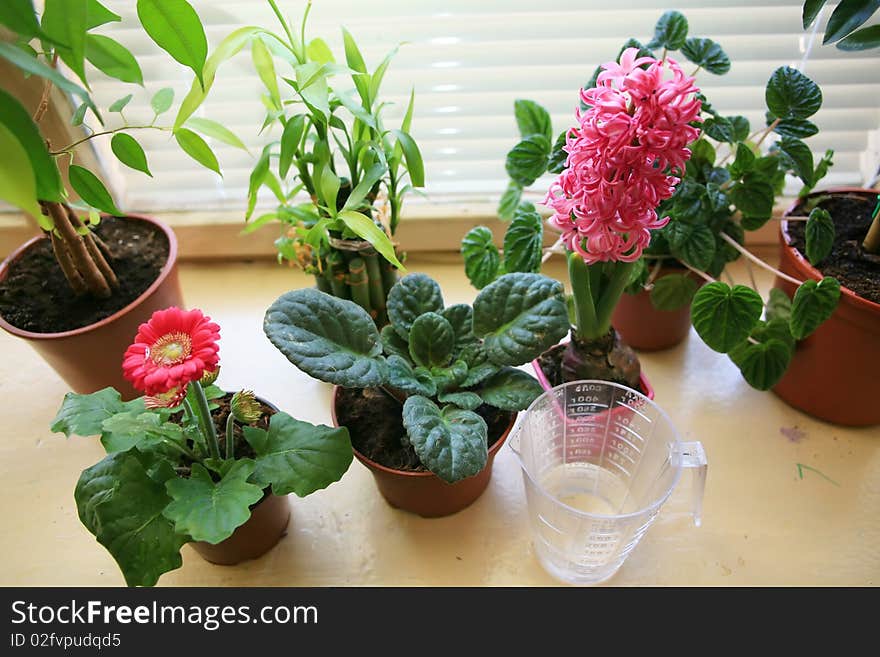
[0,251,880,586]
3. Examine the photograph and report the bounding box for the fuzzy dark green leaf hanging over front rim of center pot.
[403,396,488,483]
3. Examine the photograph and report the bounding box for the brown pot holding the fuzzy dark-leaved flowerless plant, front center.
[330,386,517,518]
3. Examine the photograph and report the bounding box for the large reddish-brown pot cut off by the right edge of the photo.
[773,188,880,426]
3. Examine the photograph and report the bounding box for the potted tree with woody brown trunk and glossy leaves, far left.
[0,0,230,399]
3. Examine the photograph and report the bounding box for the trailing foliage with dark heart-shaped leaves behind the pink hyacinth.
[462,11,838,389]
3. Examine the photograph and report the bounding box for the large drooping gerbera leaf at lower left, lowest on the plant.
[74,449,188,586]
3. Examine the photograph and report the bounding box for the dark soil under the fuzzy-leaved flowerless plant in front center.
[336,388,513,472]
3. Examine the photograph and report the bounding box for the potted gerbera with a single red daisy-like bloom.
[51,308,352,586]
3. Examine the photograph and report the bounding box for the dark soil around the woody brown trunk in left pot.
[0,217,169,333]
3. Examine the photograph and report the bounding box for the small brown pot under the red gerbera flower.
[190,397,290,566]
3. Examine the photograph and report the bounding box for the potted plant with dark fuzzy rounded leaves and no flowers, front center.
[264,273,568,516]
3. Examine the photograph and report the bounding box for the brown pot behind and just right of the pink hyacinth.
[611,268,703,351]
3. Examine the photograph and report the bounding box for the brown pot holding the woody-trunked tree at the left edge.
[0,215,184,399]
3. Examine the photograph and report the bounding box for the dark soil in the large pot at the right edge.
[788,193,880,303]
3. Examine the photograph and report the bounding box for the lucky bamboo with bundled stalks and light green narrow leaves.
[199,0,424,327]
